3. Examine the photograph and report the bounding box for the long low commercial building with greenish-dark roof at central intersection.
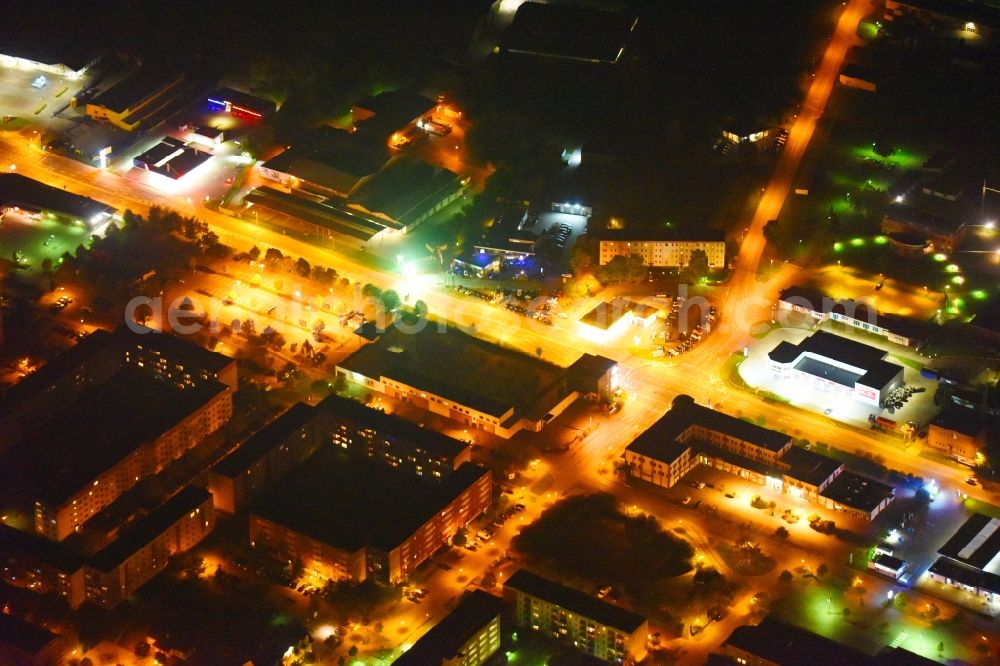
[337,325,617,438]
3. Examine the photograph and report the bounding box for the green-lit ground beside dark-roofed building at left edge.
[0,214,90,275]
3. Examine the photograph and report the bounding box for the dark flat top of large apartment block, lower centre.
[251,446,489,553]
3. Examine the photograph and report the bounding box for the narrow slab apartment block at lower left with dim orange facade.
[86,486,215,608]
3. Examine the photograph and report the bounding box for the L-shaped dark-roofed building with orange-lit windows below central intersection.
[622,395,893,520]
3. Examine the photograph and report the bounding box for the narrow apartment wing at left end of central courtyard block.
[208,402,320,513]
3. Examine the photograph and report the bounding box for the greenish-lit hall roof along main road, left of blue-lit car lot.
[349,155,463,224]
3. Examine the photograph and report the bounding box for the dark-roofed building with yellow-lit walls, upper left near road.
[87,65,184,132]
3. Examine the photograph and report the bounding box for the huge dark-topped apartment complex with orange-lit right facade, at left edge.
[0,327,237,540]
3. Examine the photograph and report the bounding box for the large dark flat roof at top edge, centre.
[500,2,639,63]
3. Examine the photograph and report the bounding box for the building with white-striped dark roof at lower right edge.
[927,513,1000,610]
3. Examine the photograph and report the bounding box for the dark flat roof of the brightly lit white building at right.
[767,331,902,389]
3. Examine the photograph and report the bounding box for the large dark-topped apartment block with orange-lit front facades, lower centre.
[250,447,493,583]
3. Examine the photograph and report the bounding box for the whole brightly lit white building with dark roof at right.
[767,331,903,408]
